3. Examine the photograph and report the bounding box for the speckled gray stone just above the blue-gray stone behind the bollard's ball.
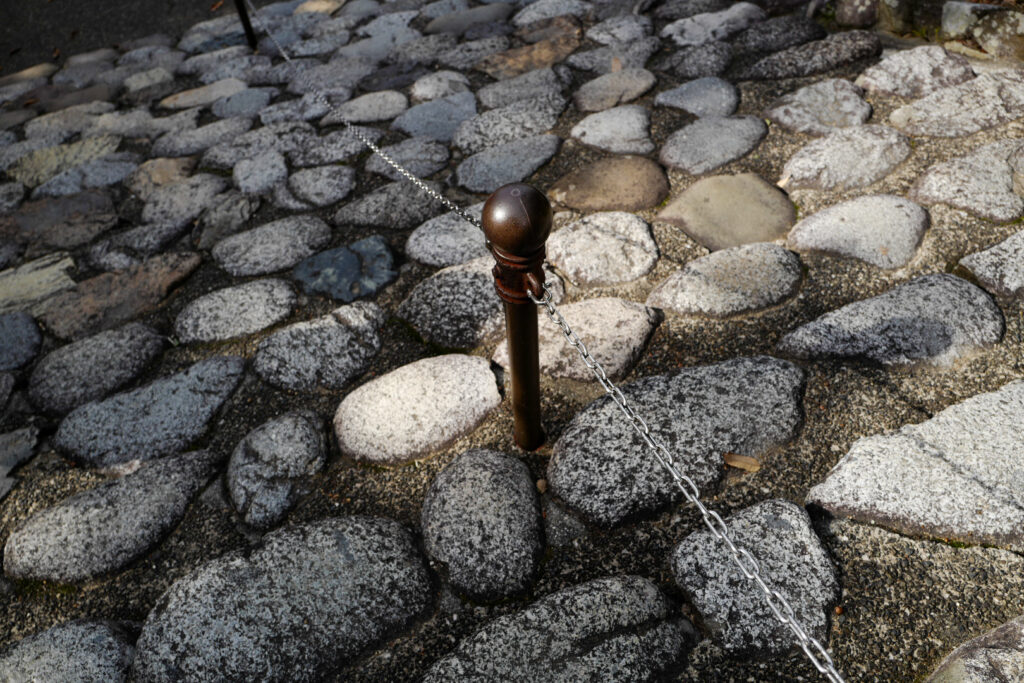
[452,95,566,155]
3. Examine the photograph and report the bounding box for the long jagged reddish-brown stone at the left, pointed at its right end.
[37,253,201,339]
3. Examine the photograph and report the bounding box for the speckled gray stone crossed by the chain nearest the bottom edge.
[672,499,840,656]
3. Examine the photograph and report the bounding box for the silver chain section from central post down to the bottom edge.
[527,284,844,683]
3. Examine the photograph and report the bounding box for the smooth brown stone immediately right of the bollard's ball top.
[548,157,669,211]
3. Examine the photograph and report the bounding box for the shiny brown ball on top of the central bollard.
[482,182,551,257]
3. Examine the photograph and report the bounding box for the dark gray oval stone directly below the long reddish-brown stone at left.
[29,323,164,415]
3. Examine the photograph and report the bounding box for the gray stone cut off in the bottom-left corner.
[0,622,135,683]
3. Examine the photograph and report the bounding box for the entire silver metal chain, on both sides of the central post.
[245,0,845,683]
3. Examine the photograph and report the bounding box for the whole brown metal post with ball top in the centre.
[482,182,551,451]
